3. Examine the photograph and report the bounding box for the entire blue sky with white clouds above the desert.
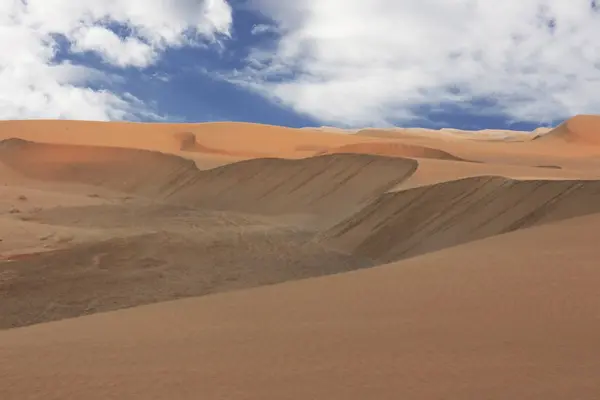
[0,0,600,130]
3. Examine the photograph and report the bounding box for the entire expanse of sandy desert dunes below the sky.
[0,116,600,399]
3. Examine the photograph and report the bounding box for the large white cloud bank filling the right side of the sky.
[237,0,600,125]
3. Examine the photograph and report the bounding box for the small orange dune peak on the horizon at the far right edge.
[538,115,600,146]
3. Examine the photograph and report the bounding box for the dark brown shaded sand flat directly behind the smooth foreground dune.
[0,227,370,329]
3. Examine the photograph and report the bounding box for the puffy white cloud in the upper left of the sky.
[0,0,232,120]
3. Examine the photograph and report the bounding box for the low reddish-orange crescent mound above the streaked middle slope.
[325,142,467,161]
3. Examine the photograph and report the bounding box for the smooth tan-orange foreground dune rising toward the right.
[0,215,600,400]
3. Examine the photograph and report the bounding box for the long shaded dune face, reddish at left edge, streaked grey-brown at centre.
[0,139,417,223]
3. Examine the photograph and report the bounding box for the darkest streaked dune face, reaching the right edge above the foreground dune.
[323,177,600,262]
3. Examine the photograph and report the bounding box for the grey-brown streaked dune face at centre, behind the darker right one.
[166,154,417,220]
